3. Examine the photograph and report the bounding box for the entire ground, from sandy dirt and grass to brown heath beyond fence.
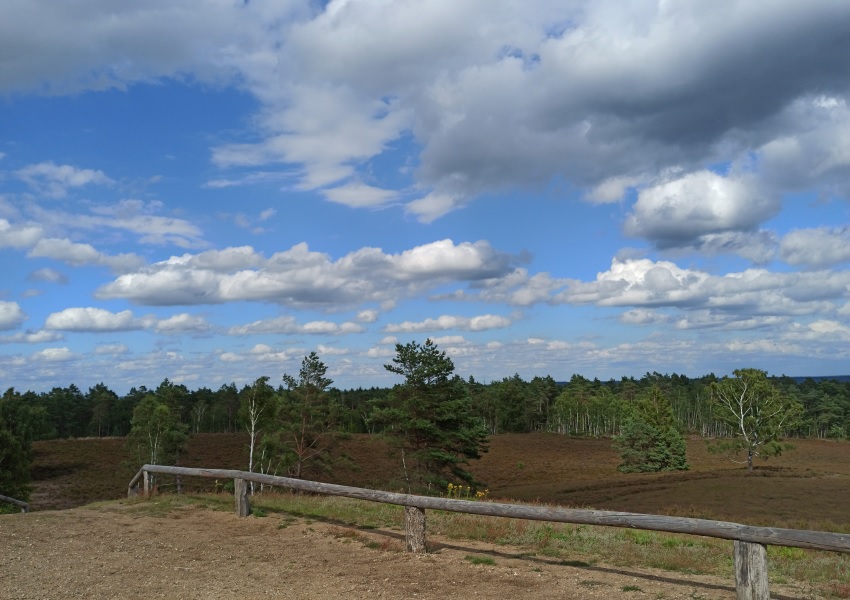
[6,434,850,600]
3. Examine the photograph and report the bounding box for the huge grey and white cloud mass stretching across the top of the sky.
[0,0,850,220]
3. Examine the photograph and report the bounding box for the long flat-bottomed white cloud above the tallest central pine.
[97,240,513,306]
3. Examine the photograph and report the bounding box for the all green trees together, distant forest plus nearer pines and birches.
[0,340,850,504]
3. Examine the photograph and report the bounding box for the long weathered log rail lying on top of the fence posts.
[136,465,850,552]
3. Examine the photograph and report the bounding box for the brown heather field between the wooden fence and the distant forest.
[32,433,850,532]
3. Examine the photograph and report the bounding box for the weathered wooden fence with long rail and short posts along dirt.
[127,465,850,600]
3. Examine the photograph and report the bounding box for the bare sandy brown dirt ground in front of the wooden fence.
[0,504,816,600]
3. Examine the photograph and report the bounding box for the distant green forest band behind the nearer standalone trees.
[2,366,850,440]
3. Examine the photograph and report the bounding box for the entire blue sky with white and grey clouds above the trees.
[0,0,850,393]
